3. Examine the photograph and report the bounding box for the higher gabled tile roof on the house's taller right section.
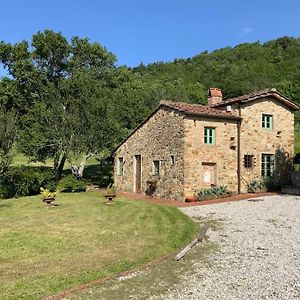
[210,88,300,110]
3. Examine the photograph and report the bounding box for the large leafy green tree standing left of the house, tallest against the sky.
[0,30,118,180]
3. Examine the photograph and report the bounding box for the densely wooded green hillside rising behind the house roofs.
[133,37,300,102]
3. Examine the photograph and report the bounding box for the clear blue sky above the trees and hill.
[0,0,300,66]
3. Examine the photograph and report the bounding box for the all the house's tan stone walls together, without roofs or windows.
[114,97,294,201]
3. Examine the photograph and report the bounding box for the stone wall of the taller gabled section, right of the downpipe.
[236,97,294,192]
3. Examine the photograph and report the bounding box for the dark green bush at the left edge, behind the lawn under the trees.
[0,166,56,198]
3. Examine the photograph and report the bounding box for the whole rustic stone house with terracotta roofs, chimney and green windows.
[114,88,299,201]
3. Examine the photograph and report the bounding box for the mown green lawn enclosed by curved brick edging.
[0,192,198,299]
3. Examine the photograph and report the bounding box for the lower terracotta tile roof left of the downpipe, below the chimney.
[159,100,241,120]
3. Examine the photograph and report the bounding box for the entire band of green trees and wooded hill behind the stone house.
[0,30,300,179]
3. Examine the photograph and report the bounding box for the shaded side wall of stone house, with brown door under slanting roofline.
[114,106,184,201]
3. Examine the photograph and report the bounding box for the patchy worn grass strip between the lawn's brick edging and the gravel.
[67,218,223,300]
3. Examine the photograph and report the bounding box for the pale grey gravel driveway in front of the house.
[152,196,300,300]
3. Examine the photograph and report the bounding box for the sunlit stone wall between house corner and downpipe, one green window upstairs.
[184,117,237,196]
